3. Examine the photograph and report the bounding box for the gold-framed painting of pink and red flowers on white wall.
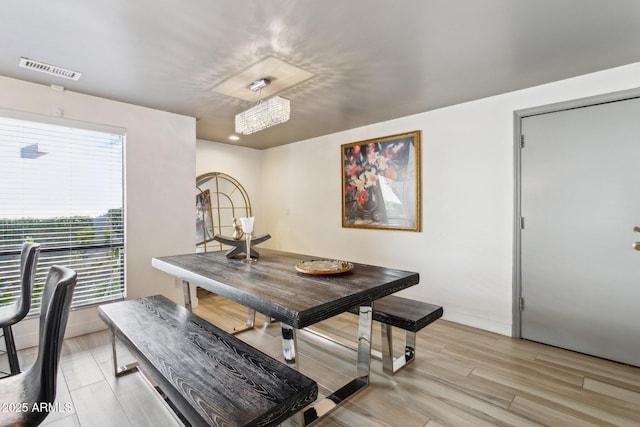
[341,131,421,231]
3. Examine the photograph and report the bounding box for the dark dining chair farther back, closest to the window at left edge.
[0,242,40,375]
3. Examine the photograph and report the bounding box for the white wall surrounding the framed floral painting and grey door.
[258,63,640,335]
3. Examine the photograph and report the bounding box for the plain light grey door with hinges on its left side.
[520,98,640,366]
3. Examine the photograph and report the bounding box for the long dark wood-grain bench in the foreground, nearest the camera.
[98,295,318,426]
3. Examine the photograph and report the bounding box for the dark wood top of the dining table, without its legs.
[152,249,420,328]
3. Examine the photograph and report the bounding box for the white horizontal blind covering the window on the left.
[0,117,125,314]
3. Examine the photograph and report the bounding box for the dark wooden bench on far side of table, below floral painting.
[349,295,443,375]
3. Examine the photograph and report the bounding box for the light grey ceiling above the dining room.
[0,0,640,148]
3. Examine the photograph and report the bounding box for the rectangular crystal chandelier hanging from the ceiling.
[236,78,291,135]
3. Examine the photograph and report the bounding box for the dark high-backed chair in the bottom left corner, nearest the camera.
[0,265,76,427]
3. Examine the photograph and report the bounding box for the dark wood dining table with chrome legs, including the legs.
[152,248,420,425]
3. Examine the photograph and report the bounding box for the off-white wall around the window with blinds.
[0,77,196,348]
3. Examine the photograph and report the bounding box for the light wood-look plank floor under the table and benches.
[5,294,640,427]
